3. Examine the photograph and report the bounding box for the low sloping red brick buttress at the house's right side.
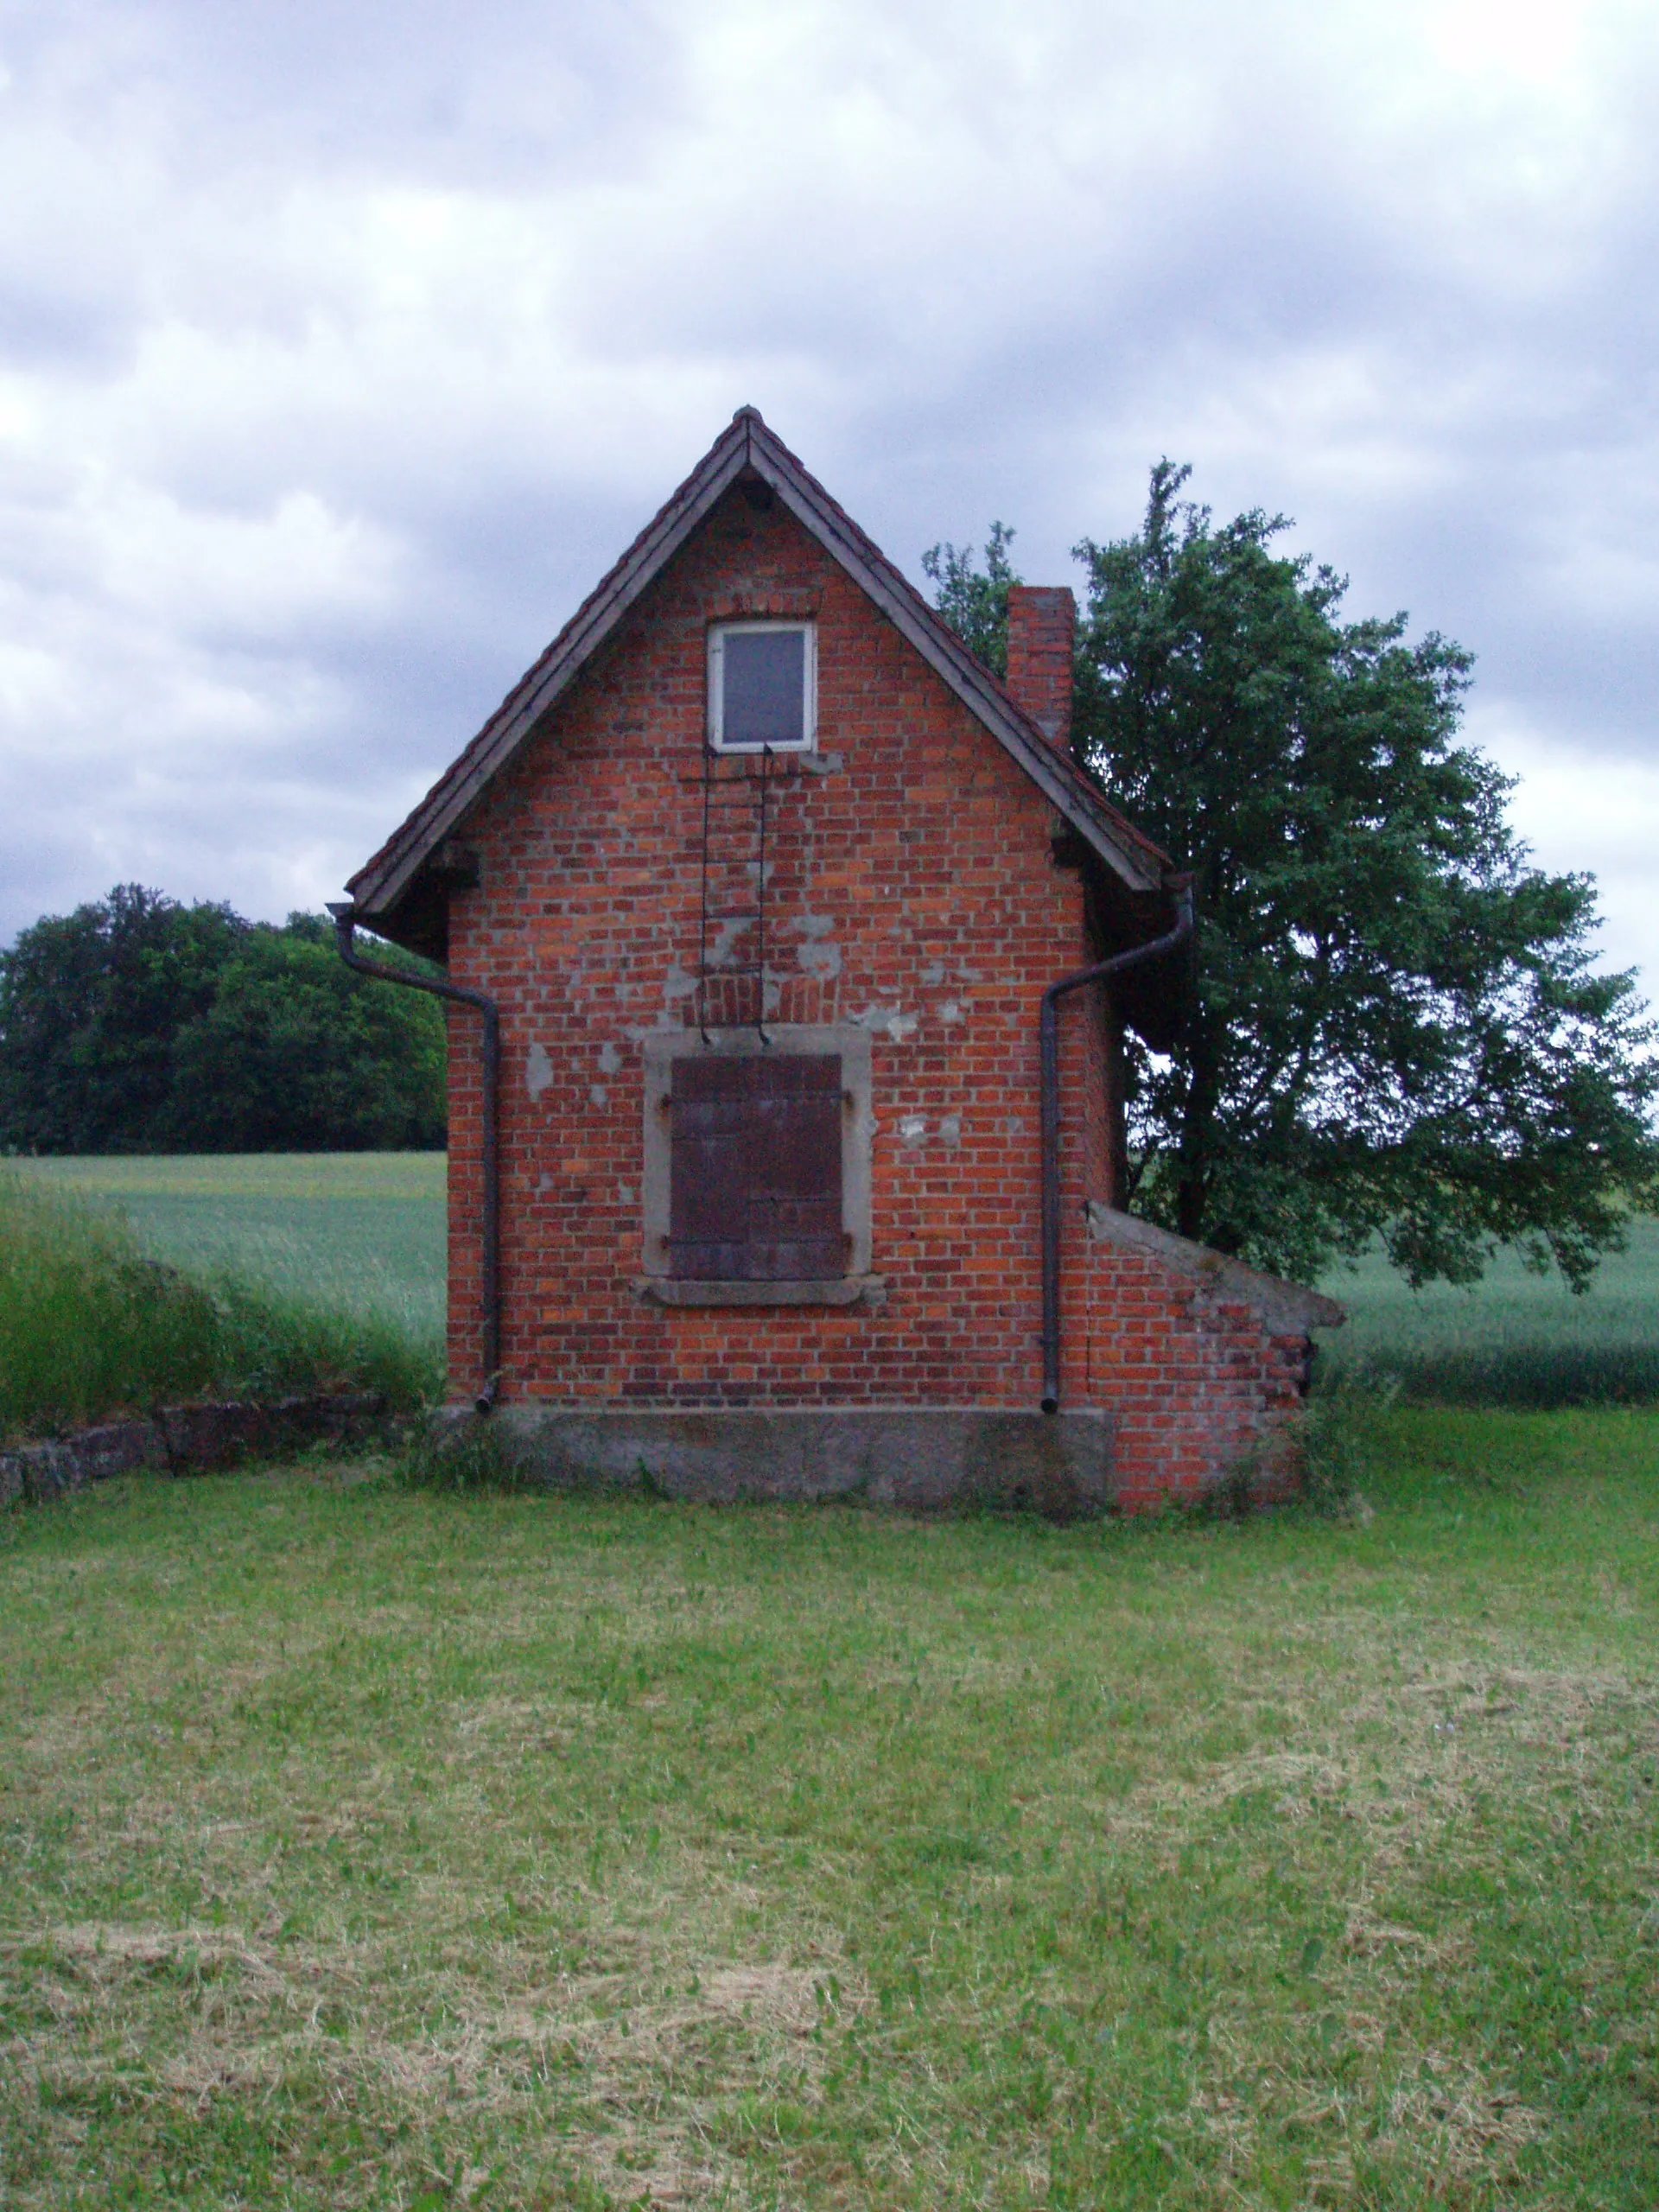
[1086,1205,1347,1510]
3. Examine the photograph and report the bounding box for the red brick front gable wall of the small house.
[449,493,1106,1407]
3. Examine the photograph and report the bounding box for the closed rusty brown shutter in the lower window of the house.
[668,1053,847,1283]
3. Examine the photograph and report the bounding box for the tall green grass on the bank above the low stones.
[0,1170,440,1440]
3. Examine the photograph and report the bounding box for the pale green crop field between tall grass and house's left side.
[16,1153,445,1343]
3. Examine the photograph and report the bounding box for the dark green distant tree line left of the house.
[0,882,445,1153]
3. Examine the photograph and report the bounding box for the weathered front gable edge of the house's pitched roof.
[347,407,1170,927]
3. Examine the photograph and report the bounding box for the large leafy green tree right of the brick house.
[936,475,1659,1287]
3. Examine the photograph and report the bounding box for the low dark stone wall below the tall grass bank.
[0,1391,385,1504]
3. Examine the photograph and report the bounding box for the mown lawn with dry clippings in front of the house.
[0,1411,1659,2212]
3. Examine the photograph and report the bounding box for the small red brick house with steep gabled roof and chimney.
[336,410,1340,1510]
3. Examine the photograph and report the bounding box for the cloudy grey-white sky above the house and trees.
[0,0,1659,982]
